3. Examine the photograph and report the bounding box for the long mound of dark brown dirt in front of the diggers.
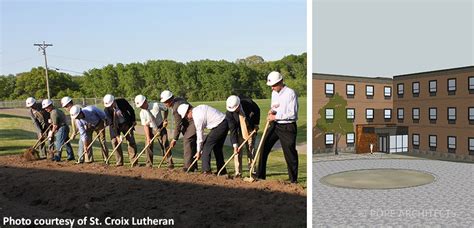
[0,155,306,227]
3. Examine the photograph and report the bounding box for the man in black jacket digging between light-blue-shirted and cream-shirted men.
[104,94,137,166]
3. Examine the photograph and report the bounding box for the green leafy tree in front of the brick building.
[316,93,354,155]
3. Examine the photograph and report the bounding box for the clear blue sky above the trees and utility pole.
[0,0,306,75]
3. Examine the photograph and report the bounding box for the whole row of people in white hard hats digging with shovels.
[26,71,298,182]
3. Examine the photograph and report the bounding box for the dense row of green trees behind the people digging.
[0,53,307,101]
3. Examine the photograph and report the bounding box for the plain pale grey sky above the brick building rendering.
[313,0,474,76]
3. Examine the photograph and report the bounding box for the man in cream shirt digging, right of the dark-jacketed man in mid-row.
[135,95,174,169]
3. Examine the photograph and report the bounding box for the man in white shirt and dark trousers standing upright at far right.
[257,71,298,183]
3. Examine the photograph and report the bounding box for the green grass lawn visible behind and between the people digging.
[0,112,307,186]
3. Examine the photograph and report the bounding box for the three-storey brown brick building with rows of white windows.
[313,66,474,157]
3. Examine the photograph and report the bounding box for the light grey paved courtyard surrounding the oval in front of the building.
[313,156,474,227]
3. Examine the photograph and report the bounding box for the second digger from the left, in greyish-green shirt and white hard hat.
[42,99,74,161]
